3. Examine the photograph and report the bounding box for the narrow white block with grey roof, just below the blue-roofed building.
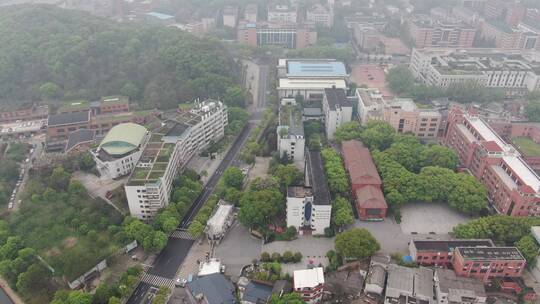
[277,105,306,161]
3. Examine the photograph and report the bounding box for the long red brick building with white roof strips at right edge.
[444,106,540,216]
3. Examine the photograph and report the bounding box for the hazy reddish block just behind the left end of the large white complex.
[409,18,476,48]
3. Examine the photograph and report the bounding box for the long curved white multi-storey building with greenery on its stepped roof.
[124,100,228,220]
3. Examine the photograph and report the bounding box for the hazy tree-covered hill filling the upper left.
[0,5,239,108]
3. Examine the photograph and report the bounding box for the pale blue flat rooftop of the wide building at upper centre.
[287,60,348,77]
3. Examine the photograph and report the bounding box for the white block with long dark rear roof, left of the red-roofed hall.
[287,150,332,234]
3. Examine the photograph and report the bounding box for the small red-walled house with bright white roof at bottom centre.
[293,267,324,304]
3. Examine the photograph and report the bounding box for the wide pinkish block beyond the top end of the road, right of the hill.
[236,22,317,49]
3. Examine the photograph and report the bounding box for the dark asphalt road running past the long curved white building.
[126,61,268,304]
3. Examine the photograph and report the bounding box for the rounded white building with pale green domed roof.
[91,123,150,179]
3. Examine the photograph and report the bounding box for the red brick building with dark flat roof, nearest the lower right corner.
[452,247,526,283]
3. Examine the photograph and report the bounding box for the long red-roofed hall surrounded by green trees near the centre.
[341,140,388,220]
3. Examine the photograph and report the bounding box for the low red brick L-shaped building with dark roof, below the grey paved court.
[409,239,494,267]
